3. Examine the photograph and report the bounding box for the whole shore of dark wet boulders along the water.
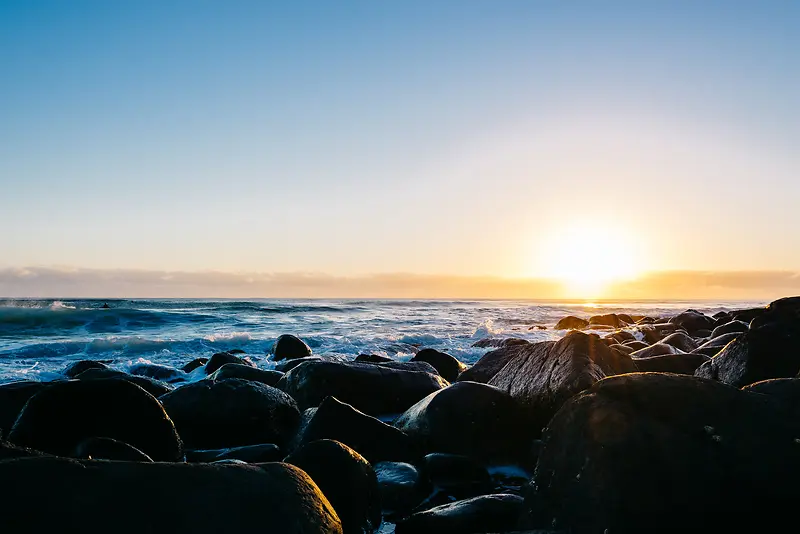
[0,297,800,534]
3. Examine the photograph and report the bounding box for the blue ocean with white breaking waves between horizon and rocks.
[0,299,767,383]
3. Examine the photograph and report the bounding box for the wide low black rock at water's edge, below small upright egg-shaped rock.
[278,361,448,415]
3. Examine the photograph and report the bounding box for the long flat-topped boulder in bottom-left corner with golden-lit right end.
[0,458,342,534]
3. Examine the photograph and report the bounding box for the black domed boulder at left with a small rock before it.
[8,380,183,462]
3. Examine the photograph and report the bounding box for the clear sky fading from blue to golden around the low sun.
[0,0,800,297]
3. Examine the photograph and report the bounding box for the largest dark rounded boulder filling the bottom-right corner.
[524,373,800,534]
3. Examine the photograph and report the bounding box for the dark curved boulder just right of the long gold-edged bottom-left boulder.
[285,439,381,534]
